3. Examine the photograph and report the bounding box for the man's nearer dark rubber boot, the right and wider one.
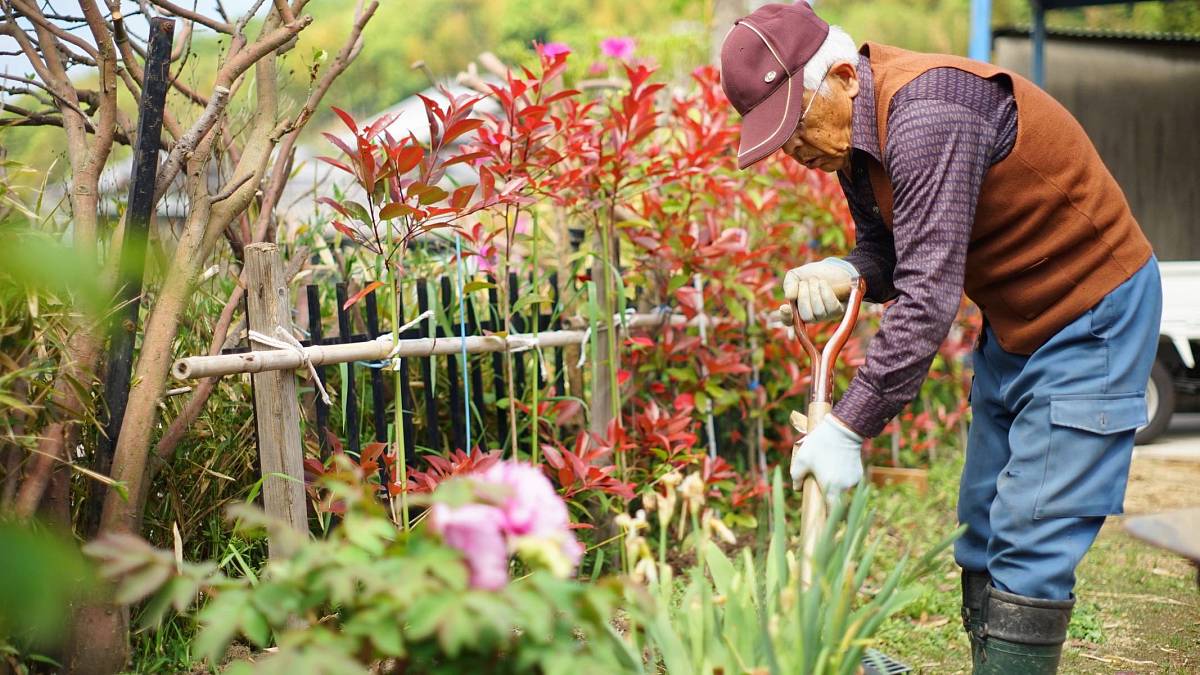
[973,586,1075,675]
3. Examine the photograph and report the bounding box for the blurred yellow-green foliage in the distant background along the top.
[0,0,1200,180]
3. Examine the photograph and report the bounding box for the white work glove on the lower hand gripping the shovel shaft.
[792,414,863,501]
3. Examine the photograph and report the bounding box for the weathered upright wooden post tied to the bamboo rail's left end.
[246,244,308,560]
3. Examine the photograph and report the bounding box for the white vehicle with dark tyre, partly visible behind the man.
[1136,261,1200,443]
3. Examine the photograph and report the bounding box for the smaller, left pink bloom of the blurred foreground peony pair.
[430,503,509,591]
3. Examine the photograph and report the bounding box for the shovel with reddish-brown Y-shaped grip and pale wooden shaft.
[791,270,866,589]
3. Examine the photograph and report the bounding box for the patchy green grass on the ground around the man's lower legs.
[878,459,1200,673]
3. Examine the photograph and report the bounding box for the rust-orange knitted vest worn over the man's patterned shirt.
[862,43,1151,354]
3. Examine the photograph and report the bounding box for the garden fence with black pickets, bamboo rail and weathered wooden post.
[173,244,707,556]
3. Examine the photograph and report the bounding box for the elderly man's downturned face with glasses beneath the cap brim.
[782,61,858,173]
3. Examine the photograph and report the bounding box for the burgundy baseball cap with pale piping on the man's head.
[721,0,829,168]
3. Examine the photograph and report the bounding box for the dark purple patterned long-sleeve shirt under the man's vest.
[834,56,1016,437]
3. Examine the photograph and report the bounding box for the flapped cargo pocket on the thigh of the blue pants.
[1033,394,1146,518]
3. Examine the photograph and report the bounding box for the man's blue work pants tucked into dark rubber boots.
[954,258,1162,599]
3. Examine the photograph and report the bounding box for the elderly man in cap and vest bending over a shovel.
[721,1,1162,674]
